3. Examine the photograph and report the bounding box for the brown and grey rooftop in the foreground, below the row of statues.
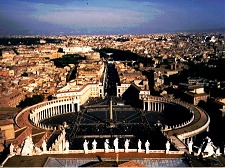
[4,153,188,167]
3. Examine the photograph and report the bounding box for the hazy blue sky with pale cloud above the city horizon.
[0,0,225,35]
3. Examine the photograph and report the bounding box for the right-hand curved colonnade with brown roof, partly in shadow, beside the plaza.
[142,96,210,140]
